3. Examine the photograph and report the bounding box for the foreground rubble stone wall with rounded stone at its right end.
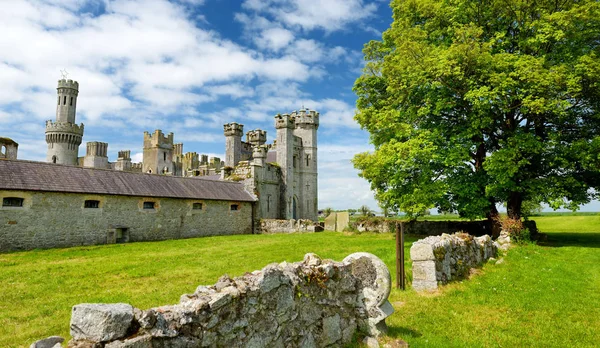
[41,253,393,348]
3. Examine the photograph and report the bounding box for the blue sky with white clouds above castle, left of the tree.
[0,0,597,210]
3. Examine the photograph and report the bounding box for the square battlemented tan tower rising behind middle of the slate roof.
[142,129,174,175]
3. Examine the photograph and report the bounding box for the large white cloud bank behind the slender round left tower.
[0,0,315,122]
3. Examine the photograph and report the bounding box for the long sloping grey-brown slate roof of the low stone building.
[0,160,255,202]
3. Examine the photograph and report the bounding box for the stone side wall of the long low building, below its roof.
[0,190,252,252]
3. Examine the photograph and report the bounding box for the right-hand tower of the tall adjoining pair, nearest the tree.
[290,109,319,221]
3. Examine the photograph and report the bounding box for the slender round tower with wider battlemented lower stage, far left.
[46,79,83,165]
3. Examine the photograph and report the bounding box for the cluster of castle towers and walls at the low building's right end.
[224,109,319,221]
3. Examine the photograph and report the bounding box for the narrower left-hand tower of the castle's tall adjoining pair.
[275,114,299,219]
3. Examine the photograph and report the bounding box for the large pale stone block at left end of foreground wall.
[71,303,133,342]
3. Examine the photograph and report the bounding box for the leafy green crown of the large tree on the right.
[354,0,600,218]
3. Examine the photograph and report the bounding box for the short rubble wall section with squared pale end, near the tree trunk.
[410,233,497,291]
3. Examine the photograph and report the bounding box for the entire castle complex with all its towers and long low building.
[0,79,319,251]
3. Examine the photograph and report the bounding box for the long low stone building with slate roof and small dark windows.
[0,160,256,252]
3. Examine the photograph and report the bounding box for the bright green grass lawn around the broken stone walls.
[0,215,600,347]
